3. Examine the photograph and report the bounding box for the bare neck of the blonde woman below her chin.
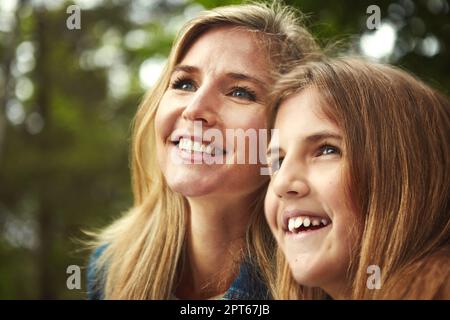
[176,194,250,299]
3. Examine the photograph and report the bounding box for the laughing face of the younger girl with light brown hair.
[265,89,356,296]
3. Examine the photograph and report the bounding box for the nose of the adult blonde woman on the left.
[182,85,220,126]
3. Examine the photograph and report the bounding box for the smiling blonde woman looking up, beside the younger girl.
[88,5,318,299]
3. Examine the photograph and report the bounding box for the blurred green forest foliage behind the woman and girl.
[0,0,450,299]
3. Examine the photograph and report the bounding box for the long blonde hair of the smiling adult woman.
[88,2,319,299]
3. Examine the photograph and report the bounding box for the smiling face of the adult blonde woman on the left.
[155,27,270,200]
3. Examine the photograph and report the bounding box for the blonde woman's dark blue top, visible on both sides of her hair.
[87,246,271,300]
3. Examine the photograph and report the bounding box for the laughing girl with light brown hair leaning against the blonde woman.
[265,58,450,299]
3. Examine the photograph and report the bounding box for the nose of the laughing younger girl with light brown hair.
[272,162,310,199]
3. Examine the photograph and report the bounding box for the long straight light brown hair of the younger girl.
[269,57,450,299]
